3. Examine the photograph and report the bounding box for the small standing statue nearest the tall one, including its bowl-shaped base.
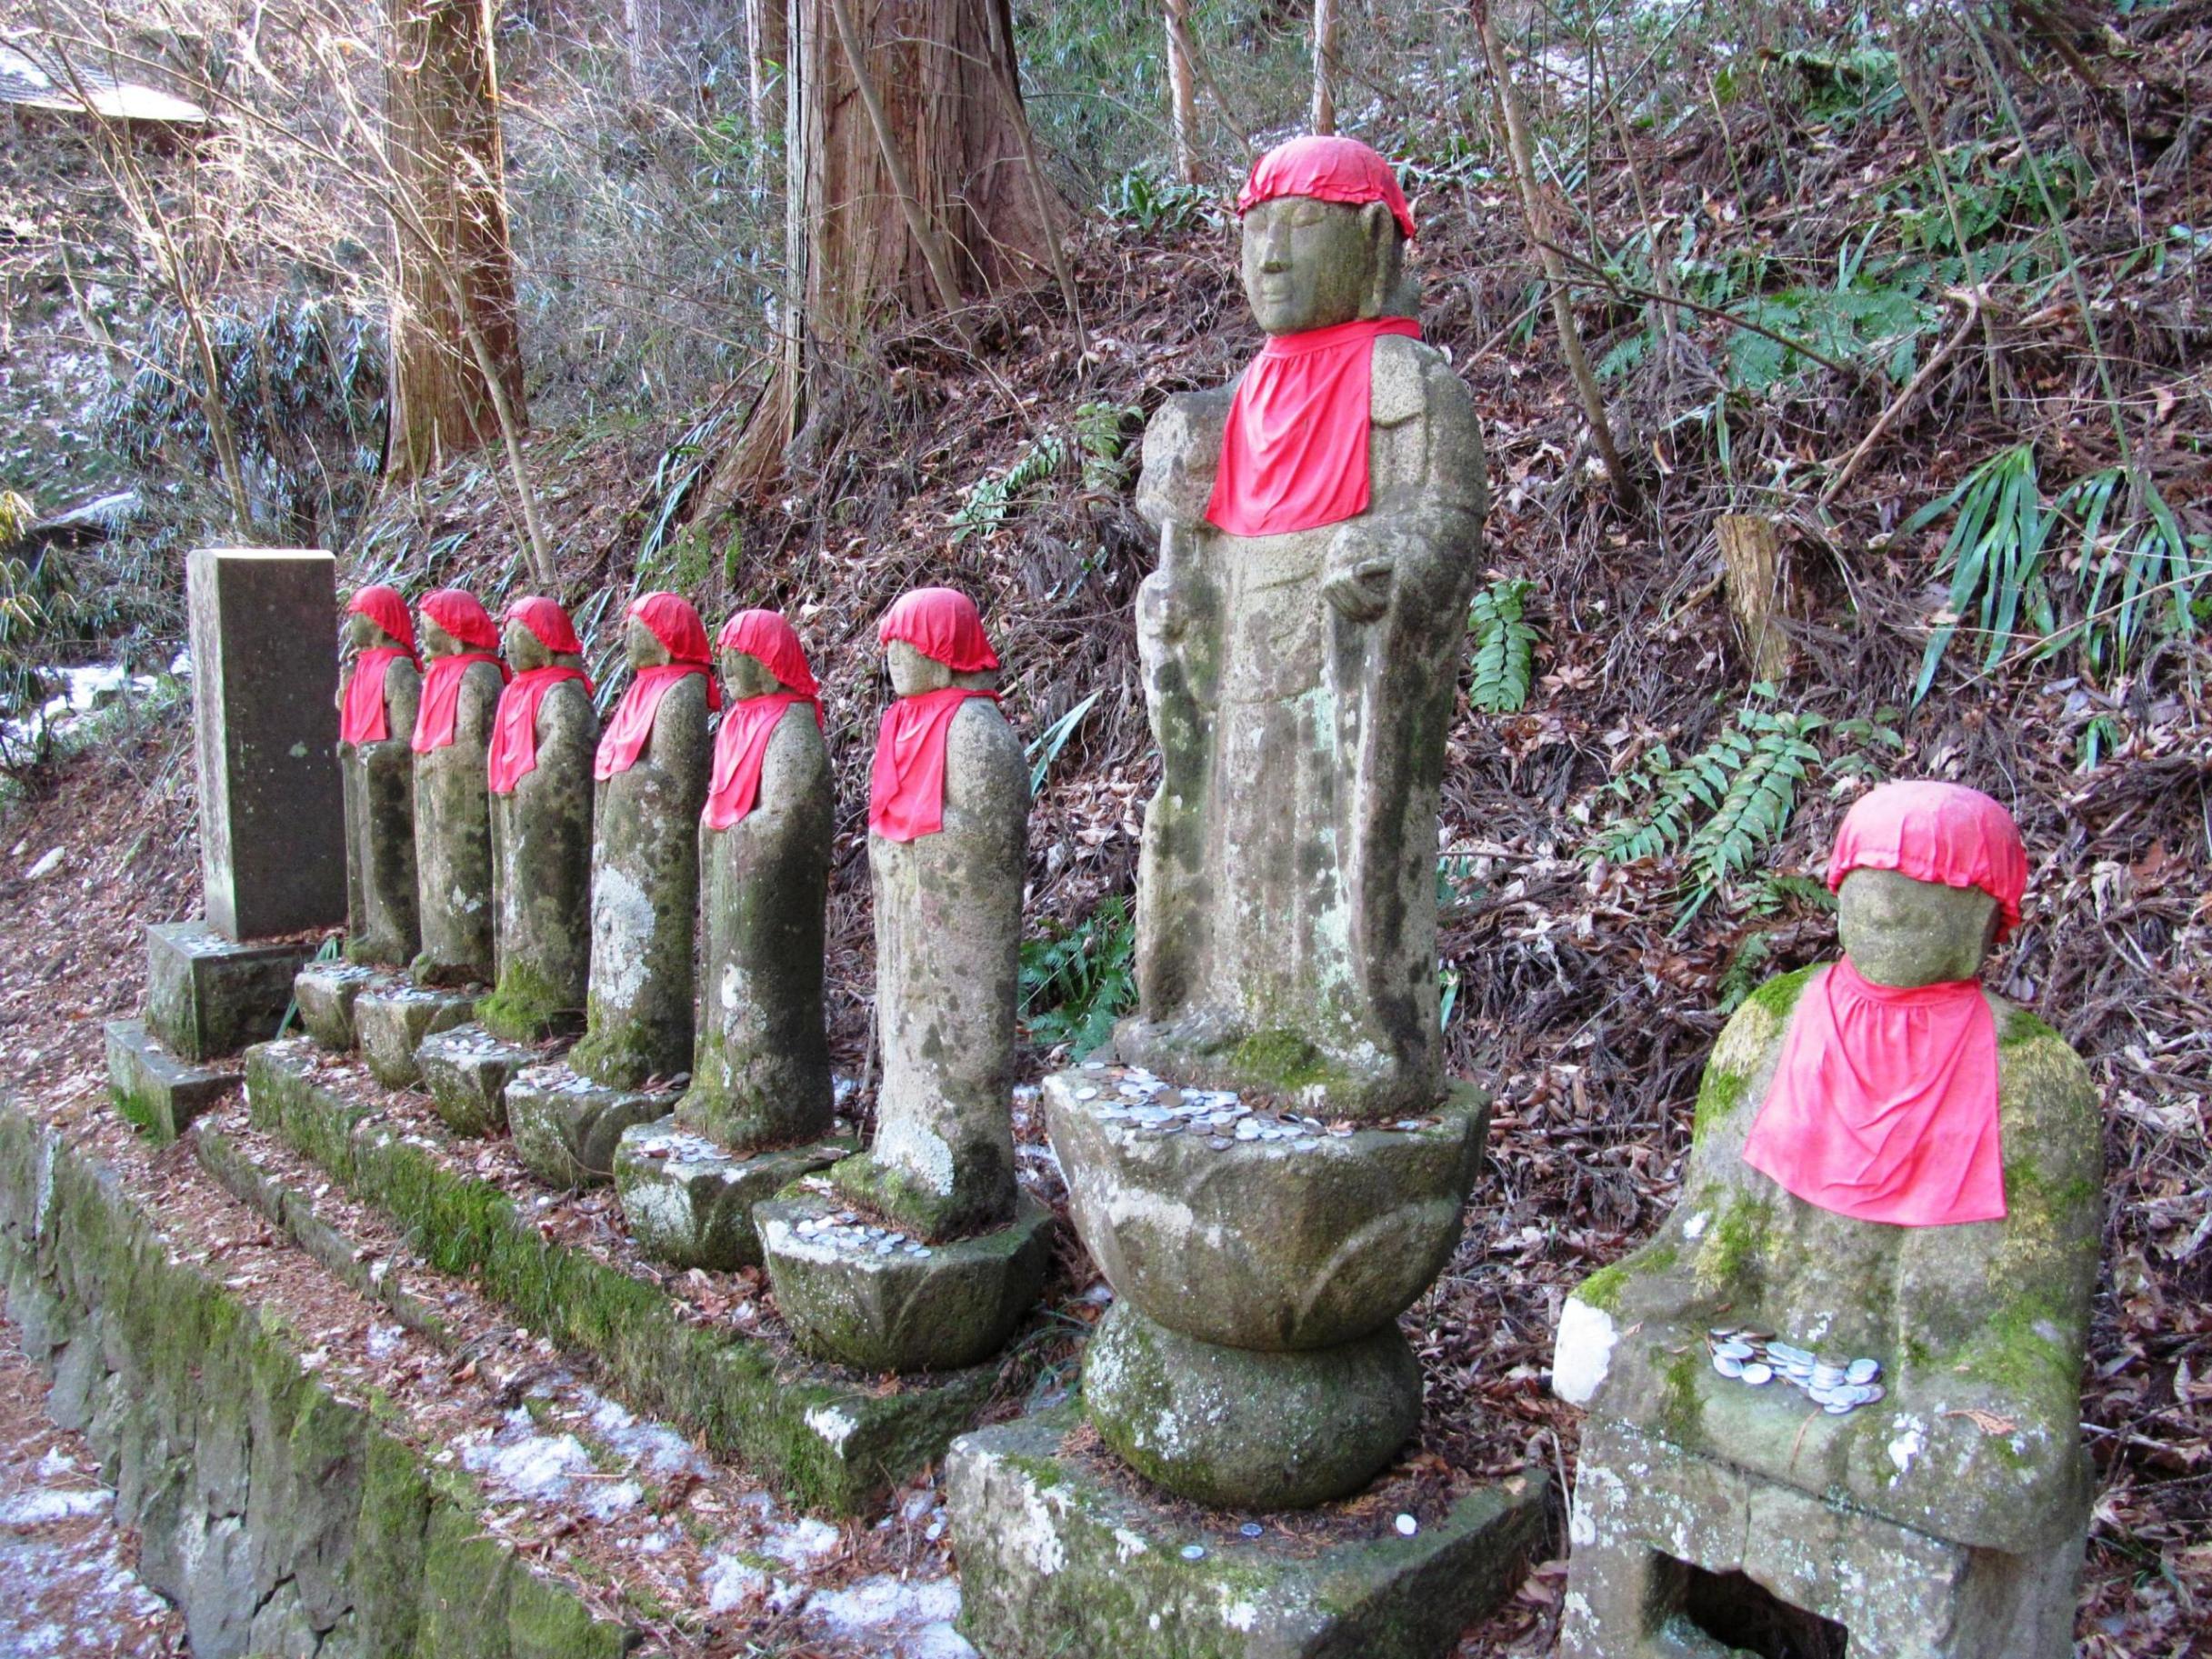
[755,588,1051,1372]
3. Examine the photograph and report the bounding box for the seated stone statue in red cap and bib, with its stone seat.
[1553,783,2104,1659]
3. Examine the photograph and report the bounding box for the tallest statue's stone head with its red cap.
[1236,137,1414,334]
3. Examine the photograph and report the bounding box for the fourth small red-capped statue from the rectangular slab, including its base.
[506,593,721,1185]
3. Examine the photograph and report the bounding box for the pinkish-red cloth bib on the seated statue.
[1743,958,2004,1228]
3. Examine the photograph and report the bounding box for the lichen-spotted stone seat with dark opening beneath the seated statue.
[1559,1420,2088,1659]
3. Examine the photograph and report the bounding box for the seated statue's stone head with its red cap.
[1827,779,2028,989]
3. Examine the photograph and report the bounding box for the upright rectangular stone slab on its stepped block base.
[106,548,345,1137]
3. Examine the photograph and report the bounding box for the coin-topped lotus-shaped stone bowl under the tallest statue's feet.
[1044,1068,1488,1349]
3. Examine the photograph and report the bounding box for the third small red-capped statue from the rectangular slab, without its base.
[475,597,599,1042]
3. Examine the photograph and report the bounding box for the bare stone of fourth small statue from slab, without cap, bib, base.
[568,617,710,1088]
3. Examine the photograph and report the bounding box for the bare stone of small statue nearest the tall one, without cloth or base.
[856,667,1028,1236]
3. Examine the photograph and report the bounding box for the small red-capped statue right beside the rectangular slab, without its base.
[338,584,423,966]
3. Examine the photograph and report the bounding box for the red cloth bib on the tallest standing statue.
[1206,316,1420,535]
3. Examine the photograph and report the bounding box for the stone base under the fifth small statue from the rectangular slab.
[615,1117,852,1272]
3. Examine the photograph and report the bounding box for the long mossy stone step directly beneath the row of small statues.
[245,1040,997,1515]
